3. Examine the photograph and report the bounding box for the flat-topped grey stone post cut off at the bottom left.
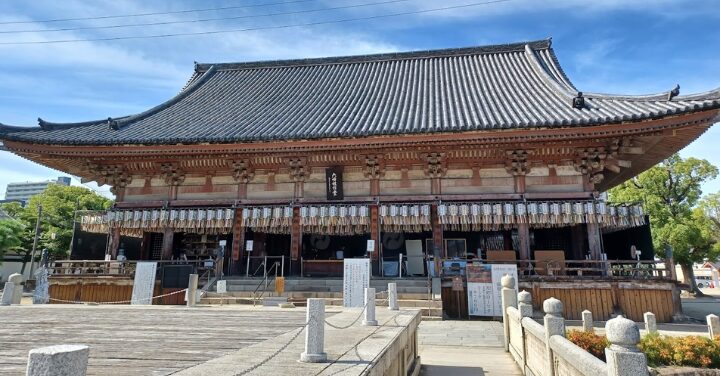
[26,345,90,376]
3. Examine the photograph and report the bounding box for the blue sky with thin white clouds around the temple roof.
[0,0,720,197]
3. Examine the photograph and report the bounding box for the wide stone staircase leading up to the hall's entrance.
[201,278,442,320]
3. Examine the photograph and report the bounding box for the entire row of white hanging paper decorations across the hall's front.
[80,201,645,235]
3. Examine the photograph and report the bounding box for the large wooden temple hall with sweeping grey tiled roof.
[0,40,720,276]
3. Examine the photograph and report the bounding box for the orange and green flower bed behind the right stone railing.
[567,330,720,368]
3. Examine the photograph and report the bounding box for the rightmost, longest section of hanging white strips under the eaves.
[438,201,645,231]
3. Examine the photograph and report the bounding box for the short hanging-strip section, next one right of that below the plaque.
[379,204,432,232]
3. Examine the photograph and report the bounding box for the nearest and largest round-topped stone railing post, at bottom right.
[605,316,648,376]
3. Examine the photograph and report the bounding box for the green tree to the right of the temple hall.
[609,154,718,294]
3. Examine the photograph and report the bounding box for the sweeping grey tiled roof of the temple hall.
[0,40,720,145]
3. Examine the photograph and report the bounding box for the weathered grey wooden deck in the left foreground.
[0,305,305,375]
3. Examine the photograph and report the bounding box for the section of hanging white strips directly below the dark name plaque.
[300,205,370,235]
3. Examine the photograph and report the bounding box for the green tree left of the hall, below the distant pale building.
[3,185,112,269]
